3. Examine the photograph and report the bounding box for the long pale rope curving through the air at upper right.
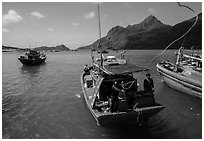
[147,2,198,68]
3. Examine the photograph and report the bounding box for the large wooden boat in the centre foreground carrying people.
[81,63,164,125]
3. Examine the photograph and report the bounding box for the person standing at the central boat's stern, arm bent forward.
[110,81,124,112]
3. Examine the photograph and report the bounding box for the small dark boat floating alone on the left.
[18,50,46,65]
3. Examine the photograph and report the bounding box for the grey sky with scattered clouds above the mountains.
[2,2,202,49]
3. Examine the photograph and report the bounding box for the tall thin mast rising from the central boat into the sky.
[98,2,103,68]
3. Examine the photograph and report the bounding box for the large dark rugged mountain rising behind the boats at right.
[78,13,202,49]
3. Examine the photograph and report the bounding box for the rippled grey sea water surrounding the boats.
[2,50,202,139]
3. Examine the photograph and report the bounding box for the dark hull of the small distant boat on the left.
[18,58,46,66]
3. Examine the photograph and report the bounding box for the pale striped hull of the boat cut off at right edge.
[157,64,202,98]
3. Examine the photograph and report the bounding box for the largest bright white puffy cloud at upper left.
[2,10,23,26]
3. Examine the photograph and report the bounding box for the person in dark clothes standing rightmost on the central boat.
[144,73,154,94]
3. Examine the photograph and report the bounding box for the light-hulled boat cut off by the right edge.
[156,47,202,98]
